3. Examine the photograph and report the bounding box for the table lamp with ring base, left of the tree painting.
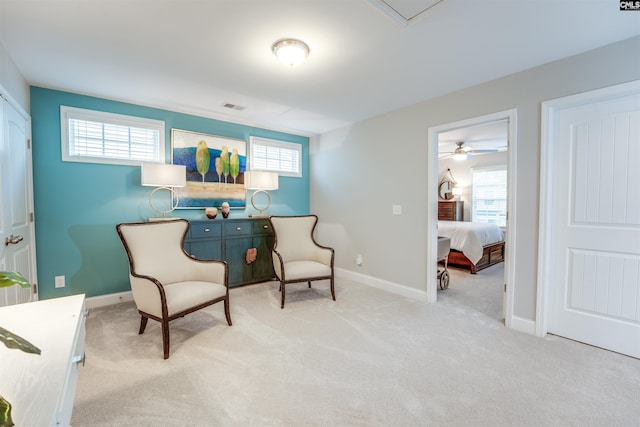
[140,163,187,220]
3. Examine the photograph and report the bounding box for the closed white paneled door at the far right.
[543,84,640,357]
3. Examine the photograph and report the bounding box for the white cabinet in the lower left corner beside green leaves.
[0,295,87,427]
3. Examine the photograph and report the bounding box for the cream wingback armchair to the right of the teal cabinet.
[269,215,336,308]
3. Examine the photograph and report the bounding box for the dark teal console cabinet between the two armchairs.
[184,218,275,287]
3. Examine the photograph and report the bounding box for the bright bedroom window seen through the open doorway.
[471,166,507,227]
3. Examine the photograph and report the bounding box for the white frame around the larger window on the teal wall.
[60,105,166,166]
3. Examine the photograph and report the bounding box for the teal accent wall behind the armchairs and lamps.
[30,87,310,299]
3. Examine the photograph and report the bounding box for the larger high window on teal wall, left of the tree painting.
[60,106,165,165]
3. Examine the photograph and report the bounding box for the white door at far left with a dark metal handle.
[0,94,36,306]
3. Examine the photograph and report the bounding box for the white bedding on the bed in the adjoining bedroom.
[438,221,504,264]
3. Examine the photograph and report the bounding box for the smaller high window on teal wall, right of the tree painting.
[249,136,302,177]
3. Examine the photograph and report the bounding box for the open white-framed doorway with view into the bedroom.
[427,110,516,326]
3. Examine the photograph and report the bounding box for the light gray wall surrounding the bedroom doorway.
[311,37,640,320]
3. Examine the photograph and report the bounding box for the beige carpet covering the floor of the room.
[72,265,640,426]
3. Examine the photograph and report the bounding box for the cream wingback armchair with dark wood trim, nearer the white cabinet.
[116,219,231,359]
